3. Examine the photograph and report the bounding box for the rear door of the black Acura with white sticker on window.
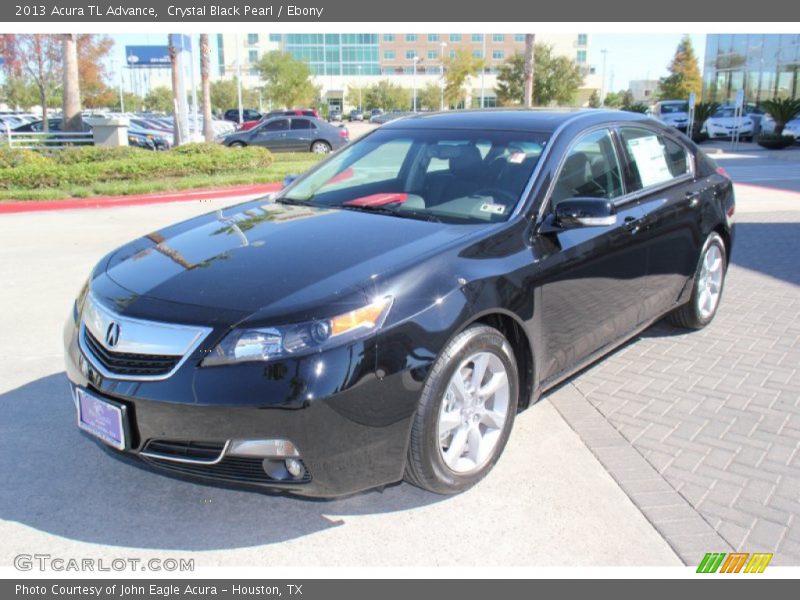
[618,125,713,318]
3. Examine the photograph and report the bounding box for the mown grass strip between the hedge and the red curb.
[0,150,322,202]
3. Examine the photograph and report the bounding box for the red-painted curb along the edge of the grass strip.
[0,183,281,214]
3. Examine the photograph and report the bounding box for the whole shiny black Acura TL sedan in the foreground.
[64,110,734,496]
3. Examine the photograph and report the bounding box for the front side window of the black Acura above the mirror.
[550,129,623,208]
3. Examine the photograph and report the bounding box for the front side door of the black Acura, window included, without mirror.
[532,128,647,380]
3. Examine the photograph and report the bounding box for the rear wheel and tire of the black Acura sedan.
[667,231,728,329]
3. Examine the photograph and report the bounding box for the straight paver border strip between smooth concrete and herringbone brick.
[547,384,734,566]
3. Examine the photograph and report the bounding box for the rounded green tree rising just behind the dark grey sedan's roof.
[258,50,319,108]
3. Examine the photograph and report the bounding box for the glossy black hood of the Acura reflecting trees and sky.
[100,199,480,315]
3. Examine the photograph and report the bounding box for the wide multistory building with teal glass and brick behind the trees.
[214,33,601,110]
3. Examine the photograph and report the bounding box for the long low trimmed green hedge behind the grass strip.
[0,144,273,189]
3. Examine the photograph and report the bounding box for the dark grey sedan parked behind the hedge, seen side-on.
[222,116,350,154]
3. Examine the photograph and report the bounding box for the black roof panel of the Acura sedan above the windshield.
[383,108,647,133]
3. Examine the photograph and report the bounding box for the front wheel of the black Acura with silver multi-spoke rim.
[405,325,519,495]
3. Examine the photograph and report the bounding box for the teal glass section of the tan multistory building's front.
[283,33,381,75]
